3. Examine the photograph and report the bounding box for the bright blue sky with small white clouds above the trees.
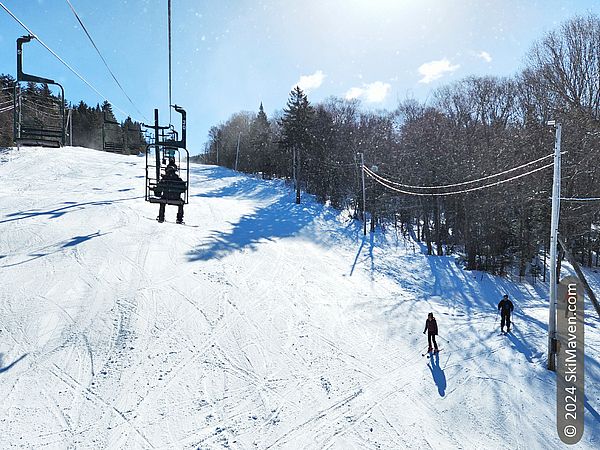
[0,0,600,154]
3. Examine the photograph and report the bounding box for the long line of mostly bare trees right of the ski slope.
[200,14,600,275]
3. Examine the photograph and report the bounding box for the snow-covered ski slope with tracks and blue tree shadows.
[0,148,600,449]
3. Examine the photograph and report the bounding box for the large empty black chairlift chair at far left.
[13,35,65,147]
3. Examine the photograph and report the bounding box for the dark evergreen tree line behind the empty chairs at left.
[0,74,146,154]
